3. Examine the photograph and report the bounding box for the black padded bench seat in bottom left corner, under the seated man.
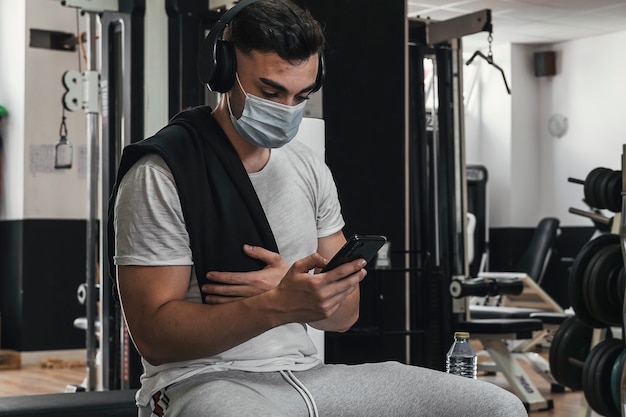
[0,389,137,417]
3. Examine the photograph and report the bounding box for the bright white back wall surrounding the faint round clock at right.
[540,32,626,225]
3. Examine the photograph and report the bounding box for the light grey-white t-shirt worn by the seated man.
[114,142,344,405]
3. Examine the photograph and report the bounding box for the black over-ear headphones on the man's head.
[197,0,326,93]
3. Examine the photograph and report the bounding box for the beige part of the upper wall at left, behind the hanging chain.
[24,1,87,219]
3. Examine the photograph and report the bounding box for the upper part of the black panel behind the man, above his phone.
[302,1,406,249]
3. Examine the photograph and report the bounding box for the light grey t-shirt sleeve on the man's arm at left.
[113,154,193,266]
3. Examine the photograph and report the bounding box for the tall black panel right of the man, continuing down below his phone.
[298,0,408,363]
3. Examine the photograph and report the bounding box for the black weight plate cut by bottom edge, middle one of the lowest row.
[582,338,624,417]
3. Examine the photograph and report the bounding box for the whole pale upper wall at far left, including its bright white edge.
[0,0,87,219]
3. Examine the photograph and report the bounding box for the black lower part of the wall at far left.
[0,220,86,352]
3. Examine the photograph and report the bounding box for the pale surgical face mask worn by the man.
[227,74,306,148]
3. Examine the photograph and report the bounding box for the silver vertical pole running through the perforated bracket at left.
[85,12,99,391]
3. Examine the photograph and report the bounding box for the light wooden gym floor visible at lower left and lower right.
[0,342,597,417]
